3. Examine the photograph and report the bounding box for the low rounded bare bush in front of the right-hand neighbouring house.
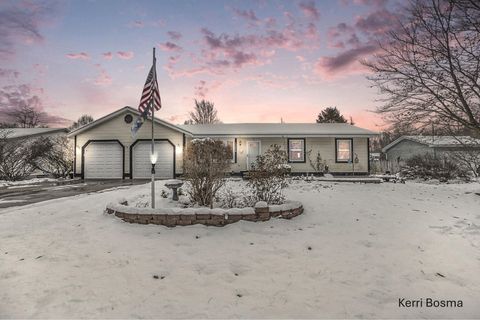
[400,153,468,181]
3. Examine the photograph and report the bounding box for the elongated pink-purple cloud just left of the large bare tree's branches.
[315,44,378,78]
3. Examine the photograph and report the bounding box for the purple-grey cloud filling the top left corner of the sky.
[0,1,57,58]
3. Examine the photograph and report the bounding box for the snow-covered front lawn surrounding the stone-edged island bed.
[0,181,480,318]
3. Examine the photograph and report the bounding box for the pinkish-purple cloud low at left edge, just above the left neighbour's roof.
[0,84,71,126]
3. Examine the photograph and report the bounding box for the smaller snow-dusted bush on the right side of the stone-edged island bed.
[248,144,290,204]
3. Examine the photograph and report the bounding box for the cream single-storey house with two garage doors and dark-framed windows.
[68,107,376,179]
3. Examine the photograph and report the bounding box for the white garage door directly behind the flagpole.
[132,141,174,179]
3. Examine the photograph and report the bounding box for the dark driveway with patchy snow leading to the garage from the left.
[0,180,148,209]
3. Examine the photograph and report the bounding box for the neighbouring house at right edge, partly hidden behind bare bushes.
[382,136,480,163]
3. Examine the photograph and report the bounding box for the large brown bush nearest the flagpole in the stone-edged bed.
[184,138,232,208]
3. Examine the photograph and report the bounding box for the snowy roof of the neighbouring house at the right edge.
[382,136,480,152]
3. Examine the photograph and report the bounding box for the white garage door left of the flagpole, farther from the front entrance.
[84,142,123,179]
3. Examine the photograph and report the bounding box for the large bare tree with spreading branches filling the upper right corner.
[364,0,480,132]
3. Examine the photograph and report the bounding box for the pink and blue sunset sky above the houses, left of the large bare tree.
[0,0,396,129]
